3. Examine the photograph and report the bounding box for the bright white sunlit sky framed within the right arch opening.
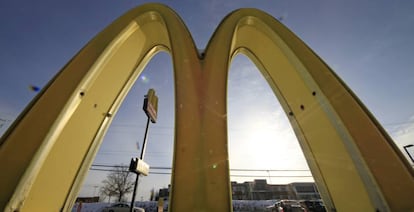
[228,56,312,183]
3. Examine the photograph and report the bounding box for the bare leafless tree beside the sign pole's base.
[101,166,135,202]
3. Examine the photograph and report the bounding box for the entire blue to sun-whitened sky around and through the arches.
[0,0,414,199]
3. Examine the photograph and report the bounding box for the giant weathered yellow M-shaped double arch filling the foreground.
[0,4,414,211]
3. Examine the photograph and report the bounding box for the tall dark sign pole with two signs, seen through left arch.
[129,89,158,212]
